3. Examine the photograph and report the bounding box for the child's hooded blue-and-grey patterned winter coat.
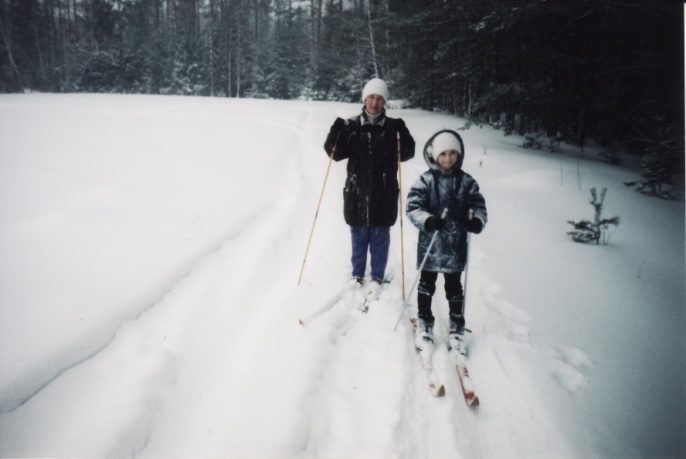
[407,135,488,273]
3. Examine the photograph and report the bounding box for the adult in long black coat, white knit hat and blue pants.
[324,78,415,295]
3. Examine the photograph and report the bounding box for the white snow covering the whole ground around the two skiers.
[0,94,686,458]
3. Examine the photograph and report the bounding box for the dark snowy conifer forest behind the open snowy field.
[0,0,684,186]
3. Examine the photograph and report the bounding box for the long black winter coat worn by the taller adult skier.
[324,111,415,227]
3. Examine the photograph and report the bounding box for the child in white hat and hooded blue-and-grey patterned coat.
[407,130,487,354]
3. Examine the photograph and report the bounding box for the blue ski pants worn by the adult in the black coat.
[350,226,391,281]
